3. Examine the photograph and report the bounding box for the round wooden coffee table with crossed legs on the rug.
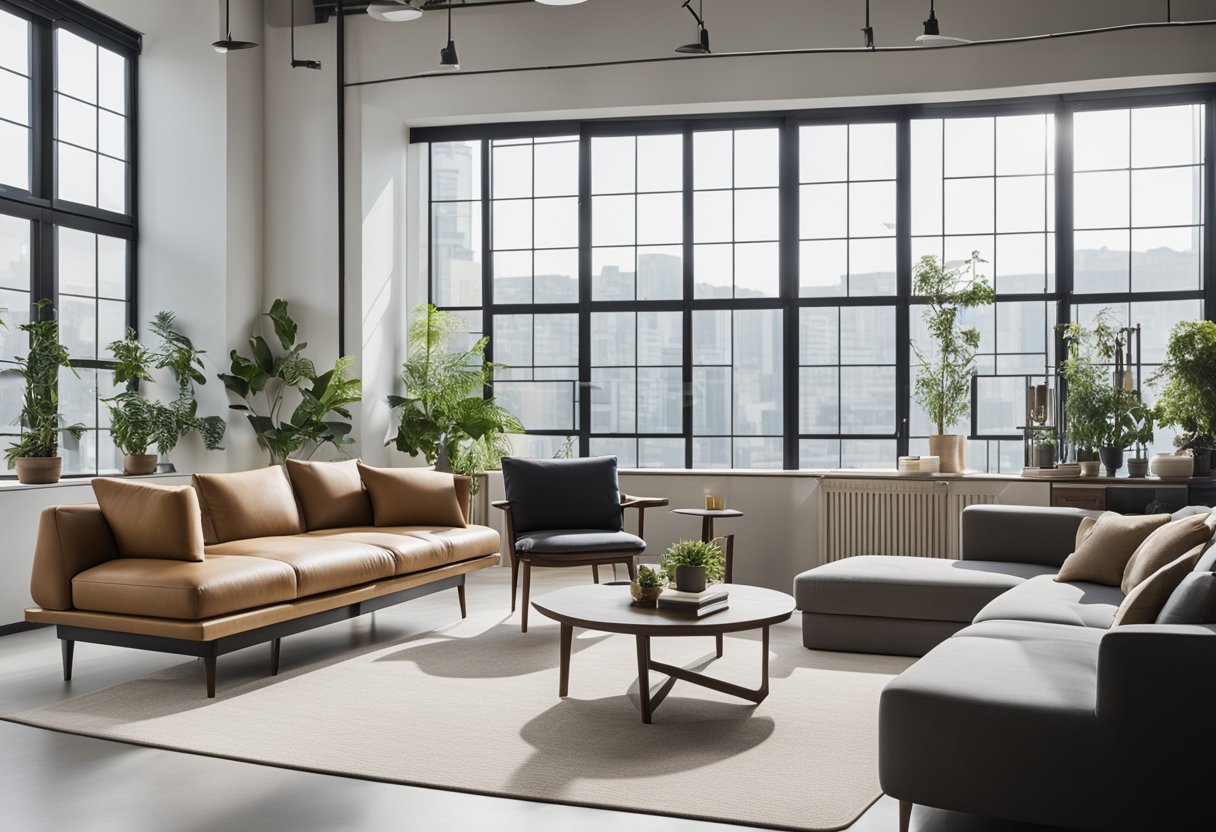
[533,584,794,723]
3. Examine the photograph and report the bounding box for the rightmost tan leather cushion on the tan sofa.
[359,462,465,527]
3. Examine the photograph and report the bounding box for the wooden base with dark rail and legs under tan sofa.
[39,556,499,698]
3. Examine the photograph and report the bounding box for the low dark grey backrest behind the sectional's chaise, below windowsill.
[959,506,1102,567]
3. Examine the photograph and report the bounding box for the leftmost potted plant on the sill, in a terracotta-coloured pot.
[0,300,84,484]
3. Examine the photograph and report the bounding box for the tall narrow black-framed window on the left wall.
[0,0,140,476]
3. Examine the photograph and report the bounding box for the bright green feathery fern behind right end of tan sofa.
[388,304,524,489]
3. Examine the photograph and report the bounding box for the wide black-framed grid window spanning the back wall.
[411,85,1216,472]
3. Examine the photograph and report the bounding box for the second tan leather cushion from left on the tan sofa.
[193,465,304,544]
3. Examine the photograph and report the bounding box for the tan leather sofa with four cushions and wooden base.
[26,461,500,697]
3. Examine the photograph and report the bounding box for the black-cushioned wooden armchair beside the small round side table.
[491,456,668,633]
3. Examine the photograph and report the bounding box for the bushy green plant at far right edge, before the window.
[1150,321,1216,477]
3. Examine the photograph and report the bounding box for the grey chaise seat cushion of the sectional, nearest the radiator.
[794,555,1055,623]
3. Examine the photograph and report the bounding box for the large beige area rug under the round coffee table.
[7,603,911,830]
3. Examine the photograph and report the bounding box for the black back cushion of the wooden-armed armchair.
[502,456,624,536]
